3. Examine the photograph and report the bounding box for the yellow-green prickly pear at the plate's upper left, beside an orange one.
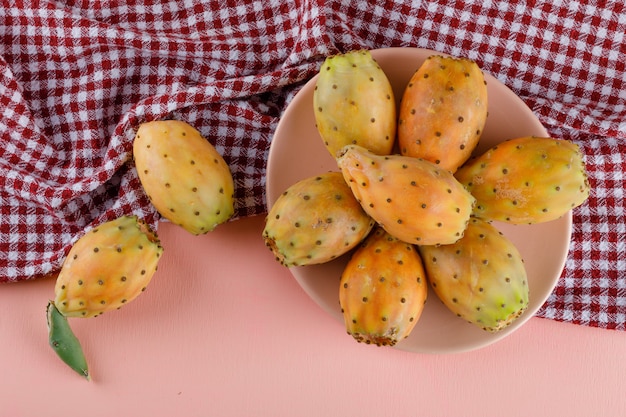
[313,50,396,157]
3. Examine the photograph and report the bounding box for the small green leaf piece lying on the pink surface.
[46,301,91,381]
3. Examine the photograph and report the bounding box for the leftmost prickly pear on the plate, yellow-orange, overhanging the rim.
[263,172,374,267]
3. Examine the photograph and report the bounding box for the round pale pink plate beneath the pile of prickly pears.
[266,48,572,353]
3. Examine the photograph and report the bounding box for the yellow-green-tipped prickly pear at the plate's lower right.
[419,218,529,332]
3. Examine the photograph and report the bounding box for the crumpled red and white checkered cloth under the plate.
[0,0,626,330]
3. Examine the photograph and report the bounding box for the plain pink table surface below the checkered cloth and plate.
[0,217,626,417]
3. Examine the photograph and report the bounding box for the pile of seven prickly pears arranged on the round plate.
[263,50,589,346]
